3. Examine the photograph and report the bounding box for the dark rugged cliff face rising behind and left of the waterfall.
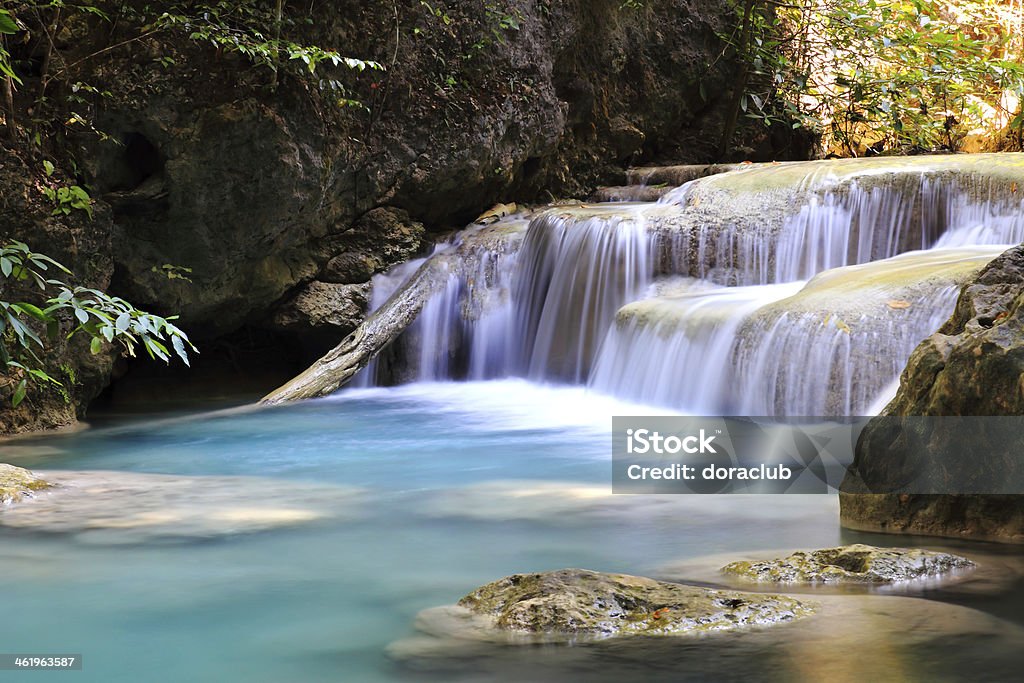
[0,0,787,432]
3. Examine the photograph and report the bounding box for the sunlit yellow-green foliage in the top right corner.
[727,0,1024,155]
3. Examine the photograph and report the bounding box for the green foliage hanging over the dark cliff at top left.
[0,0,383,145]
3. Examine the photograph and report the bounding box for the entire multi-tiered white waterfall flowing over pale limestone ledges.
[364,159,1024,416]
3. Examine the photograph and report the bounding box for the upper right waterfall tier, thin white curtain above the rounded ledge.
[660,168,1024,285]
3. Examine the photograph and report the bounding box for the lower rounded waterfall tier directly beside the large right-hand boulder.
[591,247,1004,417]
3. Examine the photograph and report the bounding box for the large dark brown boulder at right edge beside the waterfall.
[840,242,1024,543]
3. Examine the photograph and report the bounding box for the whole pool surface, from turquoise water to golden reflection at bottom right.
[0,381,1024,683]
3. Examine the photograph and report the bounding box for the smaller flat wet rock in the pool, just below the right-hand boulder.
[722,544,975,584]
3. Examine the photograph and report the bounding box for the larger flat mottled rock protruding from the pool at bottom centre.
[459,569,812,636]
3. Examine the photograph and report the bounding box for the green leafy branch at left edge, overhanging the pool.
[0,241,197,407]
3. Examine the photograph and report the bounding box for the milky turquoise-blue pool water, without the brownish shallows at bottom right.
[0,381,1019,683]
